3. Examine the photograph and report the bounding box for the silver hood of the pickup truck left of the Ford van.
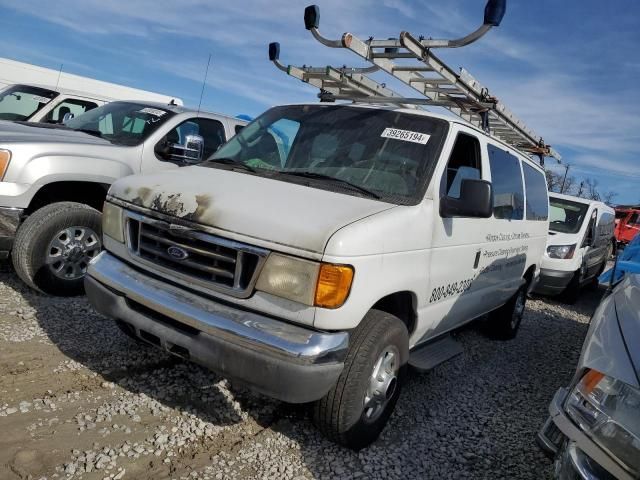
[0,120,111,145]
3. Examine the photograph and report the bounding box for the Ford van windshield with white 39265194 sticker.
[208,105,448,204]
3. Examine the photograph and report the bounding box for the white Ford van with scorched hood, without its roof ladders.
[85,104,549,448]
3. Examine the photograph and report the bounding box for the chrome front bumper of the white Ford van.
[85,252,349,403]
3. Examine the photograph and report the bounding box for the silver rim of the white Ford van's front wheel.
[363,345,400,422]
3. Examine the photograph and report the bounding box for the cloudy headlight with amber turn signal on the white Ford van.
[256,253,353,308]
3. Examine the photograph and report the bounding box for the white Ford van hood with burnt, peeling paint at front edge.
[109,166,395,254]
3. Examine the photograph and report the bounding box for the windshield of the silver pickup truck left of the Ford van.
[66,102,174,145]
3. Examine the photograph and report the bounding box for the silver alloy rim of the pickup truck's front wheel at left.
[46,226,102,280]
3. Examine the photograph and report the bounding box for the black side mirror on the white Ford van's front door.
[440,178,493,218]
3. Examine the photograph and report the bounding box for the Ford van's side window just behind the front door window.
[488,145,524,220]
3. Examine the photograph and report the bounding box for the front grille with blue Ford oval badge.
[127,214,266,296]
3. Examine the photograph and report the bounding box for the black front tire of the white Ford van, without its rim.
[312,310,409,450]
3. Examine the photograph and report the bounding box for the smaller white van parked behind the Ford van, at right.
[534,193,615,303]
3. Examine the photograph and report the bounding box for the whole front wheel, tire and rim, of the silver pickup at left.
[12,202,102,296]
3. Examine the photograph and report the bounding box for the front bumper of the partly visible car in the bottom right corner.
[538,388,633,480]
